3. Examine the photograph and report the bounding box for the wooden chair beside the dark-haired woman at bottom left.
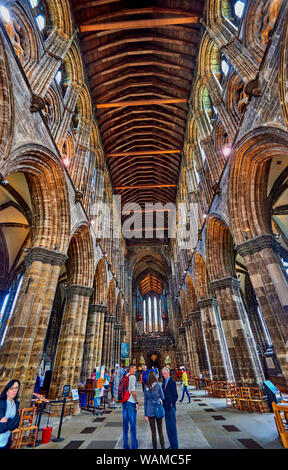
[11,406,38,449]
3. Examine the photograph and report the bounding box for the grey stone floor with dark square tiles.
[38,385,283,449]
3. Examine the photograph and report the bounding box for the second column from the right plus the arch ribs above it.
[206,216,264,385]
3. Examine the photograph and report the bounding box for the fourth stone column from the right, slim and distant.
[189,310,212,378]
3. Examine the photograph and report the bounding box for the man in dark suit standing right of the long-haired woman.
[162,367,178,449]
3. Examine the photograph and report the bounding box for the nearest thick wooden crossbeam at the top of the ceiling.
[80,14,200,33]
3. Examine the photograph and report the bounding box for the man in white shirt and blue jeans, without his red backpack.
[122,364,139,449]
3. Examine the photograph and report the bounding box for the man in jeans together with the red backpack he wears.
[118,364,139,449]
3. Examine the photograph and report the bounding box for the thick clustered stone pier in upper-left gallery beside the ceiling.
[27,29,73,111]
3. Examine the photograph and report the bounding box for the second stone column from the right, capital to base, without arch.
[211,277,264,386]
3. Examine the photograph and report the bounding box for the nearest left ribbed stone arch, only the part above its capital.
[1,144,70,253]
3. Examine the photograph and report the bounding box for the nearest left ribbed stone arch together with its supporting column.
[0,145,70,406]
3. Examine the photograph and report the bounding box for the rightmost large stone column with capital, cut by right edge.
[236,235,288,384]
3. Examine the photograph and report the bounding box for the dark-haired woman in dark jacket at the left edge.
[0,380,20,449]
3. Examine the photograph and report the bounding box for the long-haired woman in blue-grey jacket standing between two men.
[144,371,165,449]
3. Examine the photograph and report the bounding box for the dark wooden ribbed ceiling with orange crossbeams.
[71,0,205,242]
